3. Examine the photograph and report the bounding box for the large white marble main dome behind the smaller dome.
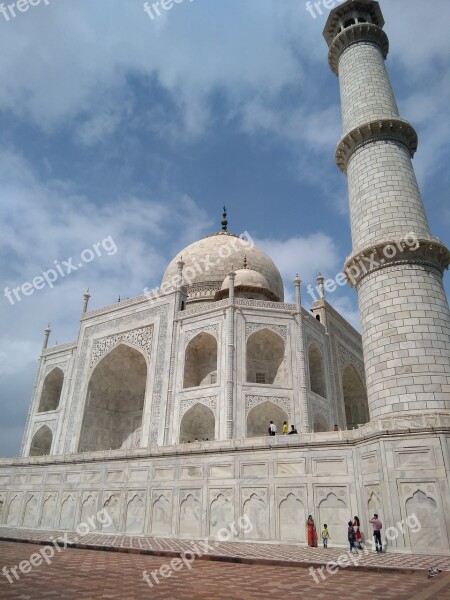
[162,231,284,302]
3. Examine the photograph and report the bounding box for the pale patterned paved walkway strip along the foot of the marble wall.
[0,527,450,572]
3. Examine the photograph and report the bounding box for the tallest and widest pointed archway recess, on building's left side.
[79,344,147,452]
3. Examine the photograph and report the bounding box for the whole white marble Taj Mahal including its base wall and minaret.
[0,0,450,554]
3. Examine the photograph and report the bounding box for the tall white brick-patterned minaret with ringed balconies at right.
[324,0,450,420]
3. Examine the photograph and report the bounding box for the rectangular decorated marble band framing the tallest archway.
[64,304,169,453]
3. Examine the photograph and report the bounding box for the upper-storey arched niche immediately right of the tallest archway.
[183,332,217,389]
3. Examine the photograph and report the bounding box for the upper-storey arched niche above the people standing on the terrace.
[246,329,287,387]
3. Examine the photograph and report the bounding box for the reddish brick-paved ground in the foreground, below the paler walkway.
[0,542,450,600]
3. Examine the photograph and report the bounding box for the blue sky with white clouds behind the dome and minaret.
[0,0,450,456]
